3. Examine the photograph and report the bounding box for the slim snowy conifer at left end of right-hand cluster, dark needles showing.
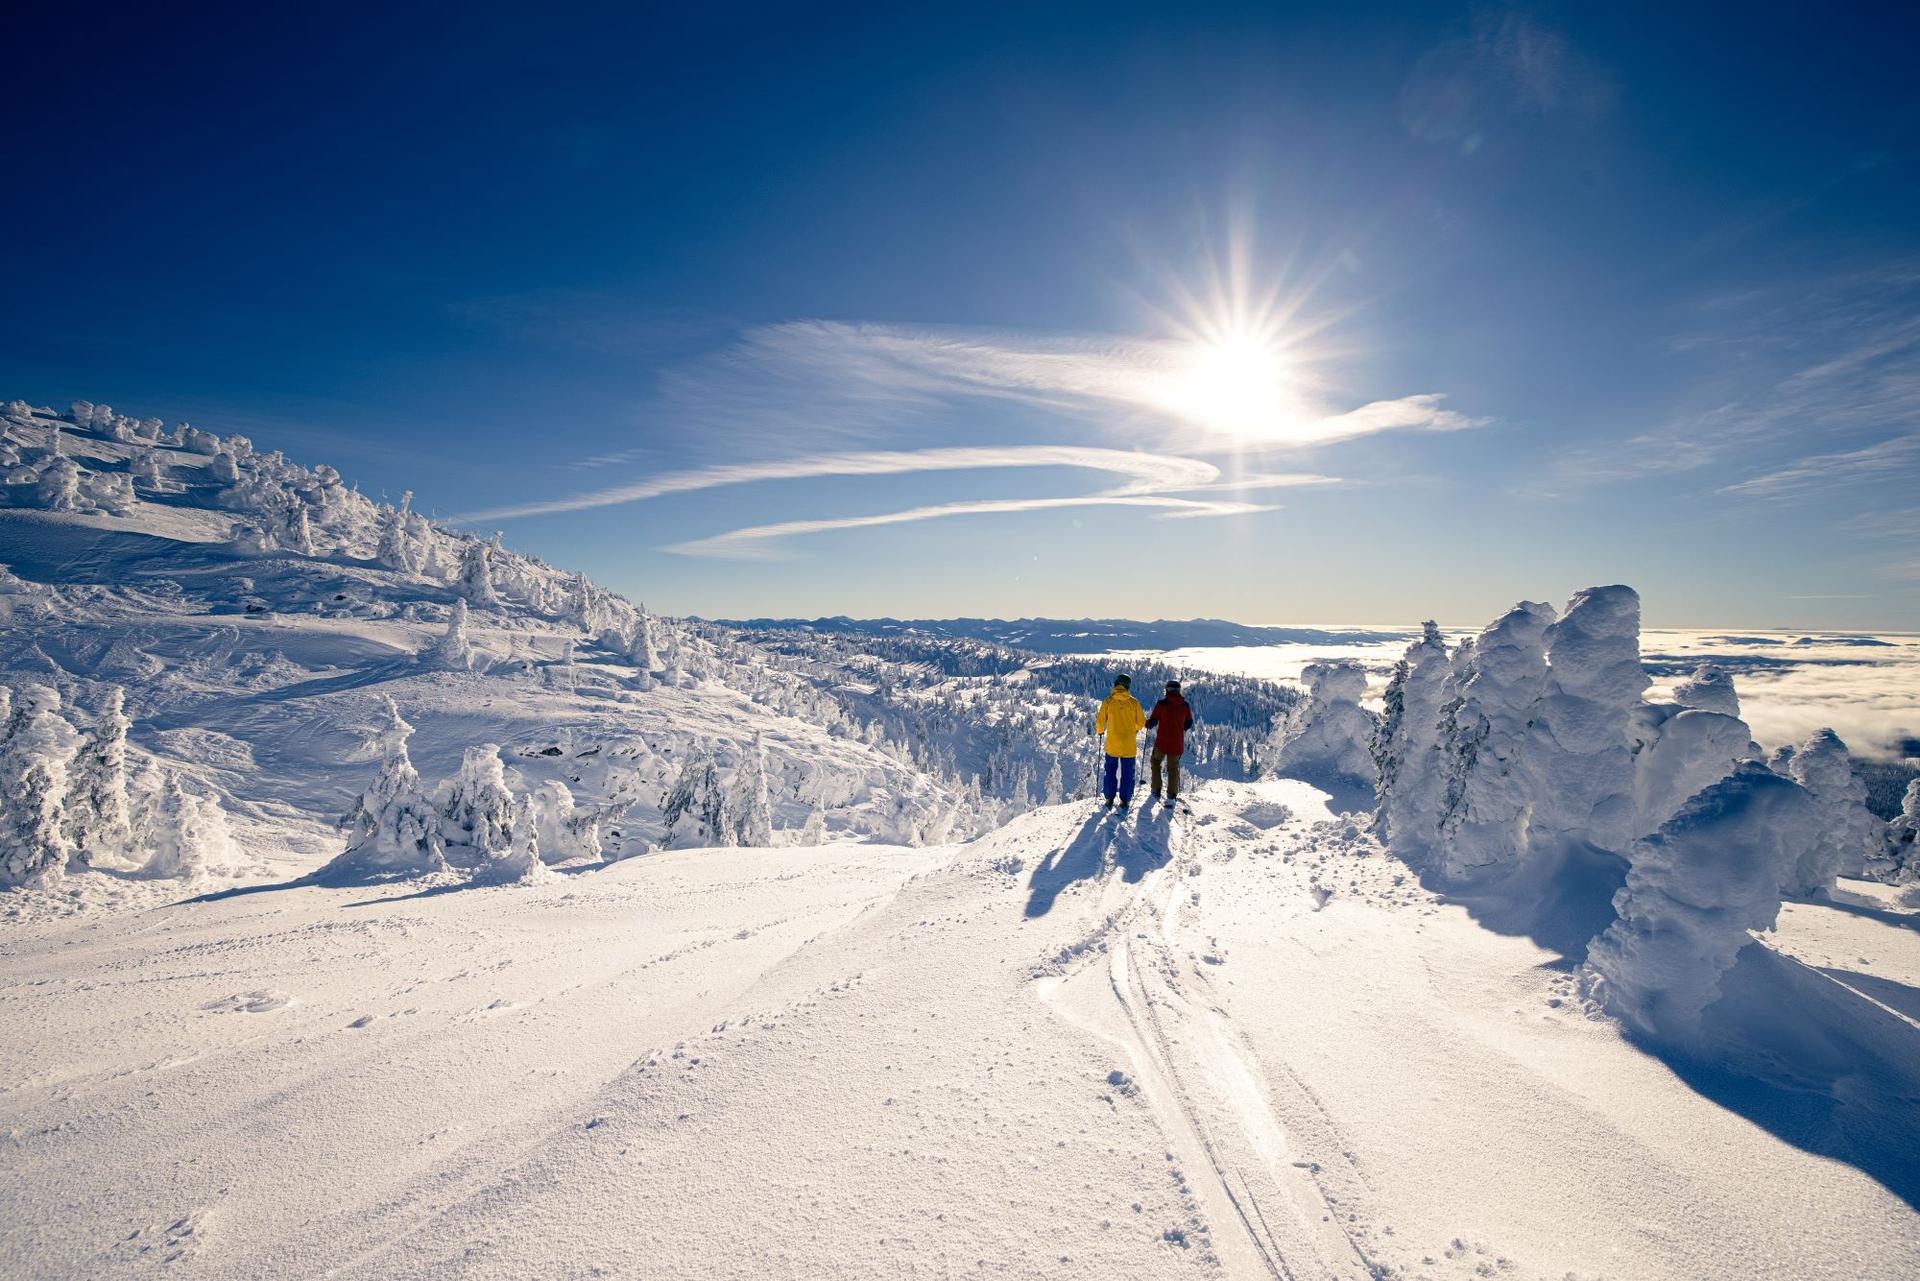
[1373,622,1453,851]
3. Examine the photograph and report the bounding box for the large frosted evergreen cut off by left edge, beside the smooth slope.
[0,686,79,885]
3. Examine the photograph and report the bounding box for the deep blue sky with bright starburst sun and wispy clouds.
[0,4,1920,628]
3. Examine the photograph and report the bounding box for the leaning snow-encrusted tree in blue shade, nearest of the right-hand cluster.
[1586,761,1820,1041]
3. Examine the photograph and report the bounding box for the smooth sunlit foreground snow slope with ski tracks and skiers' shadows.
[0,782,1920,1279]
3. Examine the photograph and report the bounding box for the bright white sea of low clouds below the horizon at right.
[1116,628,1920,757]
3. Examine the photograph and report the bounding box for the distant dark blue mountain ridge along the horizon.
[714,615,1409,653]
